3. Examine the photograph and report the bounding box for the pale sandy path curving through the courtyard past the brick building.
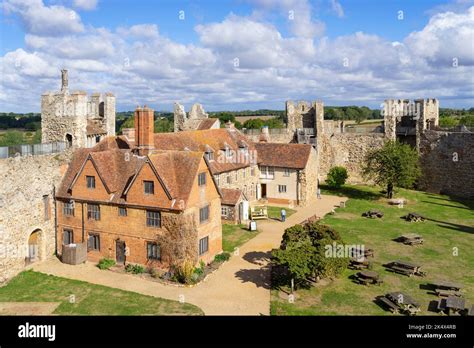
[32,195,346,315]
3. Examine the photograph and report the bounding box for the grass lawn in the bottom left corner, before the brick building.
[0,271,204,315]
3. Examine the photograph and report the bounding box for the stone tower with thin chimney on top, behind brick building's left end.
[41,70,115,147]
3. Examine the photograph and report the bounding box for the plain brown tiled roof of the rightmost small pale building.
[255,143,313,169]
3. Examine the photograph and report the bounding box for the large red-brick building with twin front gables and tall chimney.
[56,107,222,267]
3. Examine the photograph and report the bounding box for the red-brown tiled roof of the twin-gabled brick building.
[56,137,214,209]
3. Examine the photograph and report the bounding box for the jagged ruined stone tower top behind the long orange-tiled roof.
[174,103,220,132]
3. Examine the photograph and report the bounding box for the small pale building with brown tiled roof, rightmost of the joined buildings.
[255,142,318,206]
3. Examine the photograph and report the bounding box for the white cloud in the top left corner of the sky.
[3,0,84,36]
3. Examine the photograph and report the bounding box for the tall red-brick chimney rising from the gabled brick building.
[135,105,155,156]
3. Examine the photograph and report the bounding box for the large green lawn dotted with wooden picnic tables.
[271,186,474,315]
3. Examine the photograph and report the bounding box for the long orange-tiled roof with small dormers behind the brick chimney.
[155,128,255,174]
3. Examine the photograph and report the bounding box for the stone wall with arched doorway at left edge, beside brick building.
[0,151,70,283]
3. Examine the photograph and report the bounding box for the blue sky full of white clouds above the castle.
[0,0,474,112]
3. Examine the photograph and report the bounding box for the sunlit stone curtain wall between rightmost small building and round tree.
[318,133,386,183]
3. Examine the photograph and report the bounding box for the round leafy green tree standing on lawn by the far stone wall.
[362,141,421,198]
